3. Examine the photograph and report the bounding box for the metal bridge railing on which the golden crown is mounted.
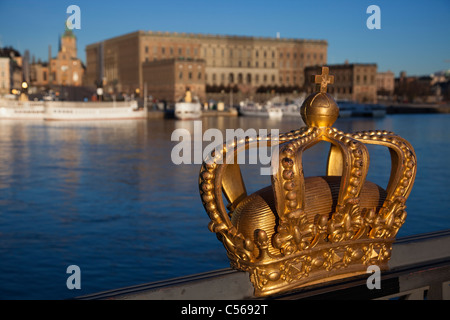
[78,230,450,300]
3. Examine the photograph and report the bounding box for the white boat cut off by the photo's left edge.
[0,99,45,120]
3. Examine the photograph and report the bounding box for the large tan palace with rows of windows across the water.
[86,31,328,102]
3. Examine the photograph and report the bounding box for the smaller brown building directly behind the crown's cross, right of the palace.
[305,62,377,103]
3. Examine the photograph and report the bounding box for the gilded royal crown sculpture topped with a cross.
[199,67,417,296]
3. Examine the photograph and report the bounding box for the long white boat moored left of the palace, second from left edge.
[44,101,147,121]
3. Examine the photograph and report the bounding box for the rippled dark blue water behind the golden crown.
[0,115,450,299]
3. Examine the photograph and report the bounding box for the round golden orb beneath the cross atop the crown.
[300,92,339,127]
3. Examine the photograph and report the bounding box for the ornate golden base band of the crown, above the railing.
[229,239,394,297]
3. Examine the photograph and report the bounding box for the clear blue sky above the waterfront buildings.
[0,0,450,75]
